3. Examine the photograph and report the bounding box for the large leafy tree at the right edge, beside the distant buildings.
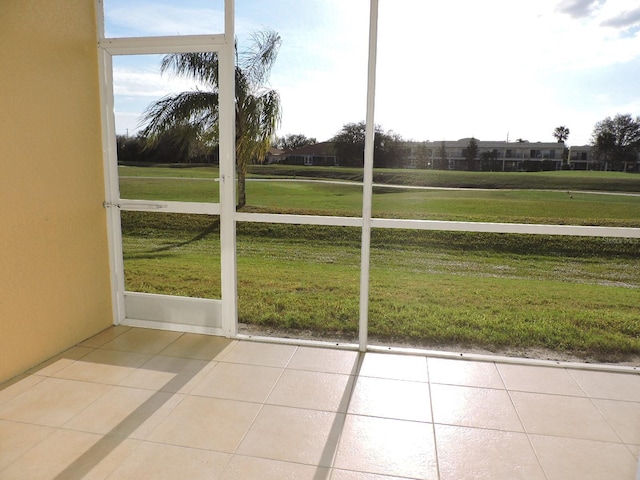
[591,114,640,171]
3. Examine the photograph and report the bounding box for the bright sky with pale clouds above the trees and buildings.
[104,0,640,145]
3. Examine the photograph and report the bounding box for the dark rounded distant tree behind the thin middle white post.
[331,122,406,168]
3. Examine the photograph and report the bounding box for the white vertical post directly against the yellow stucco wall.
[95,0,125,325]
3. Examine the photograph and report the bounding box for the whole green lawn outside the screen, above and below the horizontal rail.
[121,169,640,361]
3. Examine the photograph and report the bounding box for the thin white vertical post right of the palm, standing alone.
[358,0,378,352]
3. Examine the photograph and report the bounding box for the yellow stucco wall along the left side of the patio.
[0,0,112,381]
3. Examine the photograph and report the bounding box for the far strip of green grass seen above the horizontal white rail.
[120,167,640,227]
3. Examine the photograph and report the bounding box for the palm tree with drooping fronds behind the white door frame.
[141,30,281,208]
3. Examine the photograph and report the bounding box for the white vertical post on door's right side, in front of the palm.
[218,0,238,337]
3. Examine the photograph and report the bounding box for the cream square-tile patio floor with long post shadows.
[0,327,640,480]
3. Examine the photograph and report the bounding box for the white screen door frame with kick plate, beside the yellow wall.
[96,0,237,337]
